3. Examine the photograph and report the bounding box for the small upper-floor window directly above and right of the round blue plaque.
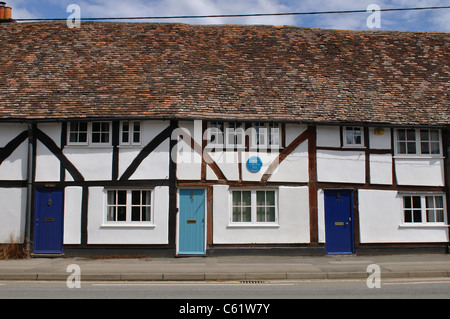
[251,123,281,150]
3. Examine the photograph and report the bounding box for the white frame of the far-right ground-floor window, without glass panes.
[400,193,448,227]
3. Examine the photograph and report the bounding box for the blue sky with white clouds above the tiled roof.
[2,0,450,32]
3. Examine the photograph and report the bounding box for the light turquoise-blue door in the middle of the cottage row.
[178,189,205,255]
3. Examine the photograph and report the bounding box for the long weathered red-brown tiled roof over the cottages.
[0,22,450,126]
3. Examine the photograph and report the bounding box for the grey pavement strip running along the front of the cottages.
[0,254,450,281]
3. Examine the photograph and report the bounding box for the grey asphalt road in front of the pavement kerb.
[0,278,450,300]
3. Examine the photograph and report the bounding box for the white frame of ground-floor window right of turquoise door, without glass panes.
[228,188,279,227]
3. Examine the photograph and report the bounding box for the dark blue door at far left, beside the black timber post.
[33,189,64,254]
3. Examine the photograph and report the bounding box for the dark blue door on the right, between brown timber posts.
[325,190,353,254]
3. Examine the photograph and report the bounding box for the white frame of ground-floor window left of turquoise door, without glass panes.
[102,188,155,227]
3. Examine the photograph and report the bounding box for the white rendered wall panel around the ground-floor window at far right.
[358,190,449,243]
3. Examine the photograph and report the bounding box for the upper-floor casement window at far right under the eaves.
[396,129,442,156]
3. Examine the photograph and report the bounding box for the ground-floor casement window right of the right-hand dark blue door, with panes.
[403,194,446,225]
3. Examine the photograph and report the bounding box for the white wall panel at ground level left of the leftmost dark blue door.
[0,188,27,243]
